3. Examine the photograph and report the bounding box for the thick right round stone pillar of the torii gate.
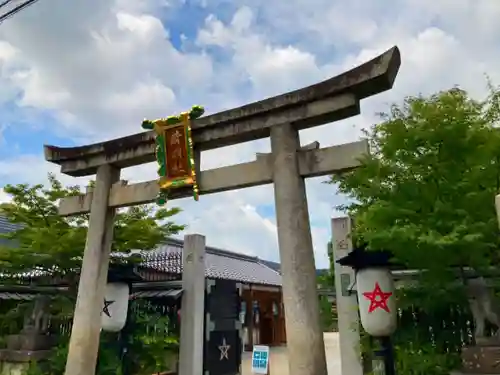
[271,124,328,375]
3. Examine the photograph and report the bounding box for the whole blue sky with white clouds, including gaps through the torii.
[0,0,500,267]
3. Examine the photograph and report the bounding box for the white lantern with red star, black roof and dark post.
[337,248,397,375]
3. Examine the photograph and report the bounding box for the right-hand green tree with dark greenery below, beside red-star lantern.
[330,86,500,375]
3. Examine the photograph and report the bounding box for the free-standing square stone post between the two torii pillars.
[179,234,205,375]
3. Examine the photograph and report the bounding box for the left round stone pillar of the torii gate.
[65,164,120,375]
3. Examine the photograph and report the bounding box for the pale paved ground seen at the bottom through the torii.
[242,332,340,375]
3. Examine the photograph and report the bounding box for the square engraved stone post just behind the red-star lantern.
[332,217,363,375]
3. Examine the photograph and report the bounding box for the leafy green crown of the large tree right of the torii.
[330,85,500,277]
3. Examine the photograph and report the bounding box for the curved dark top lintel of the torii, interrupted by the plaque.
[44,47,401,177]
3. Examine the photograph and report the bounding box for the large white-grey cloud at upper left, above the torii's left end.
[0,0,212,139]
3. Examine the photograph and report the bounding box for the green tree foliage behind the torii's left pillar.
[0,175,185,276]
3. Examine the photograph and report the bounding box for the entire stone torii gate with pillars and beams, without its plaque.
[45,47,401,375]
